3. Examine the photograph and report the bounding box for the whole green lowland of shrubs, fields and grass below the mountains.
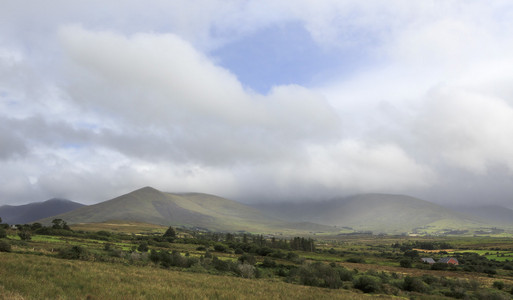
[0,219,513,299]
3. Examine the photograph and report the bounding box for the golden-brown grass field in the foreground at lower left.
[0,253,388,299]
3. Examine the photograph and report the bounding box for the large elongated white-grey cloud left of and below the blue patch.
[61,27,339,162]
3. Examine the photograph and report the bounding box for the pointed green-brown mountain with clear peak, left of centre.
[42,187,333,232]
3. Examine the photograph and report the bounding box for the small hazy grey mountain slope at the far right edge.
[451,205,513,225]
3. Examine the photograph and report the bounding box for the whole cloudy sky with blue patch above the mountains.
[0,0,513,208]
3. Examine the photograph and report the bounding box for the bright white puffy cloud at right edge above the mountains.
[418,88,513,174]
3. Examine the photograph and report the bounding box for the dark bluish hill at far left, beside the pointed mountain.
[0,198,84,224]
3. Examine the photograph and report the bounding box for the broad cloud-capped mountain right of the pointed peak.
[254,194,486,233]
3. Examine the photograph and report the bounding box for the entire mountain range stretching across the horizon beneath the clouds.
[0,187,513,235]
